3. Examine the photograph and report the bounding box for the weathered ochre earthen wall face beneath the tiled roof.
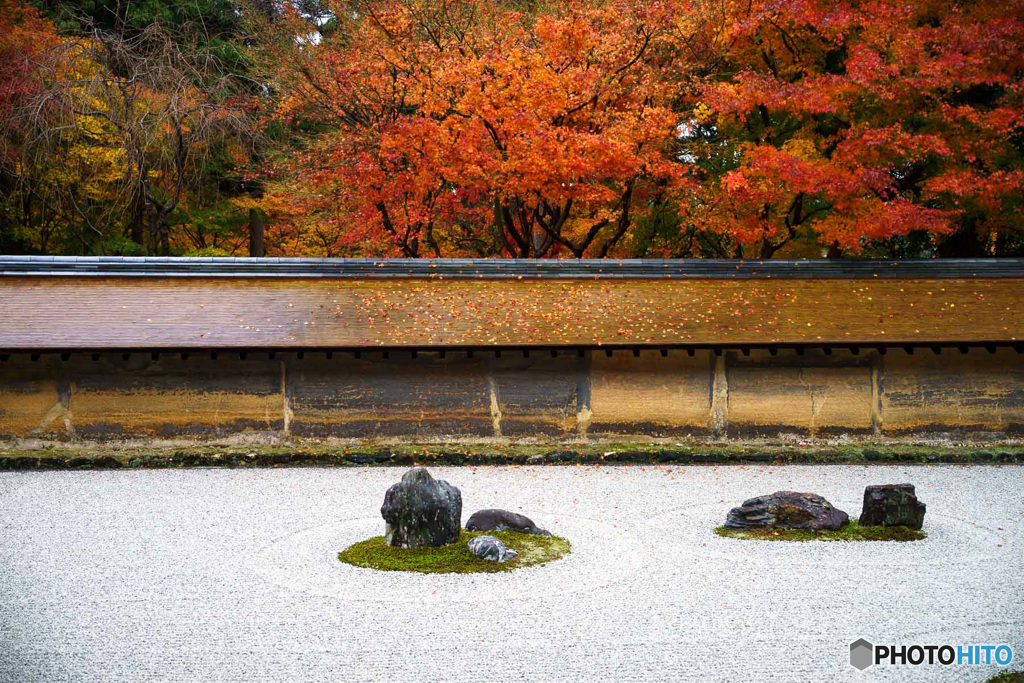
[0,348,1024,439]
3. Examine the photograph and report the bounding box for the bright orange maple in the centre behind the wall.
[260,0,687,257]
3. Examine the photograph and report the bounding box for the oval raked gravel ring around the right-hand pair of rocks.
[638,501,1014,566]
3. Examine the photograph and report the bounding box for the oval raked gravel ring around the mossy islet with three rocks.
[253,511,644,602]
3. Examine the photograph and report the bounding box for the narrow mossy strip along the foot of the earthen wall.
[0,442,1024,471]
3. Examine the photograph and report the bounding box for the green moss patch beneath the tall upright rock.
[338,529,571,573]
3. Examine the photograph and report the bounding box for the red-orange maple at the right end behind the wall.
[686,0,1024,257]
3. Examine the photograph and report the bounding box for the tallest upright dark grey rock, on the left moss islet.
[381,467,462,548]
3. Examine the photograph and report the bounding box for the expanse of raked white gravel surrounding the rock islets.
[0,465,1024,683]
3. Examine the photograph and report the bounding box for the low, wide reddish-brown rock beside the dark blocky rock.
[725,490,850,531]
